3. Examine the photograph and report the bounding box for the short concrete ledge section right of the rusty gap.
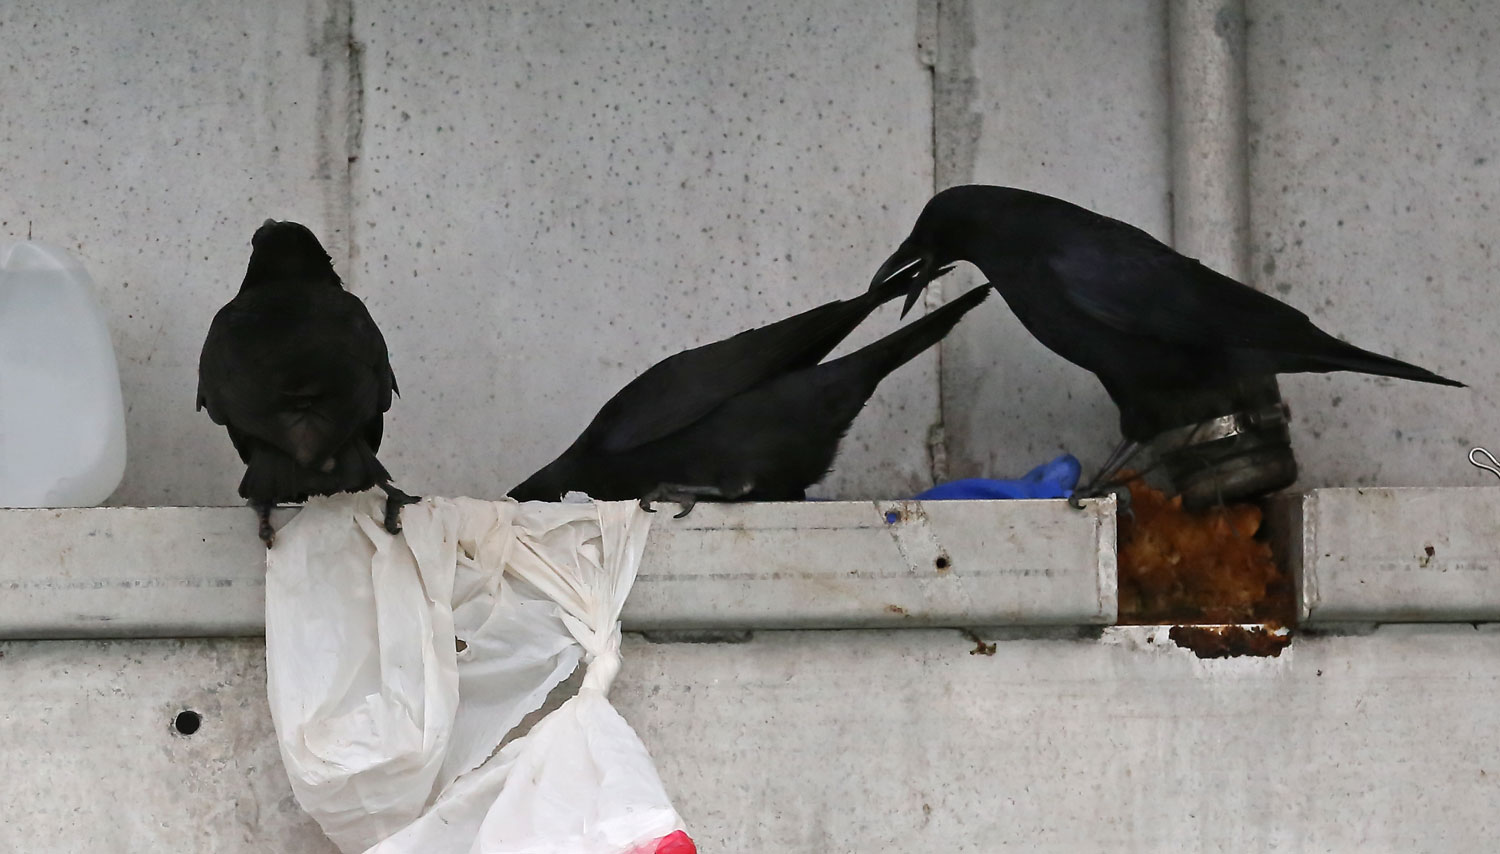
[1268,488,1500,624]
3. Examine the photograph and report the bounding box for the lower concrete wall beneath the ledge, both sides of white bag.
[0,626,1500,854]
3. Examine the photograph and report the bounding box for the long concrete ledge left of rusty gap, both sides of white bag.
[0,498,1116,639]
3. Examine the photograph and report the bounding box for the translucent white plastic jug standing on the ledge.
[0,243,125,507]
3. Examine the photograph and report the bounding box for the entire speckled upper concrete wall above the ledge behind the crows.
[0,0,1500,504]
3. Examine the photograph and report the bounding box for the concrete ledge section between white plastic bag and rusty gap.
[621,497,1118,630]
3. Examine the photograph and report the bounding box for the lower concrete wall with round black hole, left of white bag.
[0,641,338,854]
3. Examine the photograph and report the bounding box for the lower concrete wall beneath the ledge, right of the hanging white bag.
[615,626,1500,854]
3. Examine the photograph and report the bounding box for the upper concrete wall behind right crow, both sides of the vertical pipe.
[936,0,1500,488]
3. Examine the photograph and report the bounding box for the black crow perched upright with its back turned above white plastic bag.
[198,219,417,548]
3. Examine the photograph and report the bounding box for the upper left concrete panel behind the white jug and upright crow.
[0,0,350,504]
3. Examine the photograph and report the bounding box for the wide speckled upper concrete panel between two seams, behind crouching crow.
[354,0,936,497]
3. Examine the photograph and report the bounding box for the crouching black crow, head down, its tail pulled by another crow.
[510,285,989,515]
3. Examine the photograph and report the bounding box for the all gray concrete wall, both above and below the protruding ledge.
[0,8,1500,854]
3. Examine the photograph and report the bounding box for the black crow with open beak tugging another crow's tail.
[870,185,1463,485]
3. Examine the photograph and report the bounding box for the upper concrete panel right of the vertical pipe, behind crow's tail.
[1248,0,1500,488]
